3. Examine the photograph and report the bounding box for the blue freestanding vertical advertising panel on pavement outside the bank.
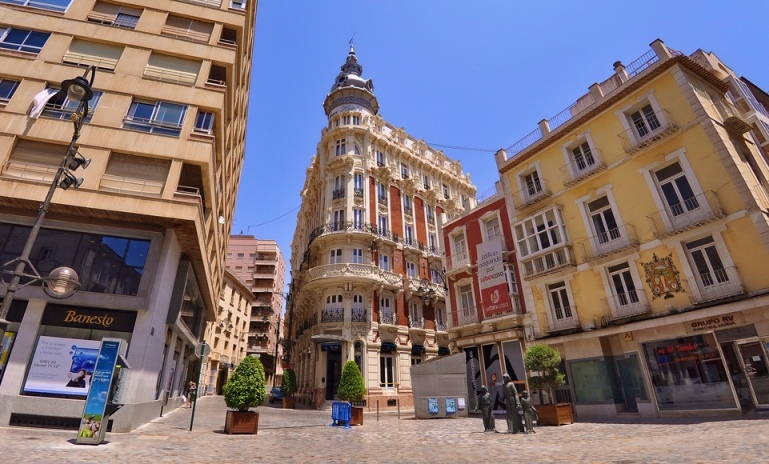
[76,338,122,445]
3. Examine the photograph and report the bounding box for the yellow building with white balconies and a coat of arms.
[497,40,769,417]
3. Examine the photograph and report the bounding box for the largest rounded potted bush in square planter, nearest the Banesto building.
[223,356,267,434]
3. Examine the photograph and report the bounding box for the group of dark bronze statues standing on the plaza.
[475,374,537,433]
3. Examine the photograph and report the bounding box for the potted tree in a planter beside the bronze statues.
[523,344,574,425]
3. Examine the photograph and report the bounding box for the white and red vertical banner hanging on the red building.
[476,236,513,316]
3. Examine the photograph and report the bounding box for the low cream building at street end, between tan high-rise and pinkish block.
[200,270,255,395]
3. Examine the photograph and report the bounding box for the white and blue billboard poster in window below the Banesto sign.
[24,335,100,396]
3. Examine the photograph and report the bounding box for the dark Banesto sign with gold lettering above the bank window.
[41,305,136,332]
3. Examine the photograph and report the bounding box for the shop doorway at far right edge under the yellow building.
[721,340,769,409]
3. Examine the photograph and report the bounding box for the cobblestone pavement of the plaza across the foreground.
[0,397,769,464]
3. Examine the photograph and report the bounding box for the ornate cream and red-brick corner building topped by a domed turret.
[287,47,475,407]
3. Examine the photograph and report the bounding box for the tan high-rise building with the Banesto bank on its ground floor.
[0,0,256,431]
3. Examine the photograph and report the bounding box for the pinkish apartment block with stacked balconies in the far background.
[227,235,286,385]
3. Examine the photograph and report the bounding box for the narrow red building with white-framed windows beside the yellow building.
[443,183,530,410]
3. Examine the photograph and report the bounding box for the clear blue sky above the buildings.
[232,0,769,290]
